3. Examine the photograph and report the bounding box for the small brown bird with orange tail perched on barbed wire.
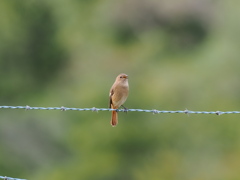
[109,74,129,127]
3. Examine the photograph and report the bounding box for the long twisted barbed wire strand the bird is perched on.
[0,105,240,115]
